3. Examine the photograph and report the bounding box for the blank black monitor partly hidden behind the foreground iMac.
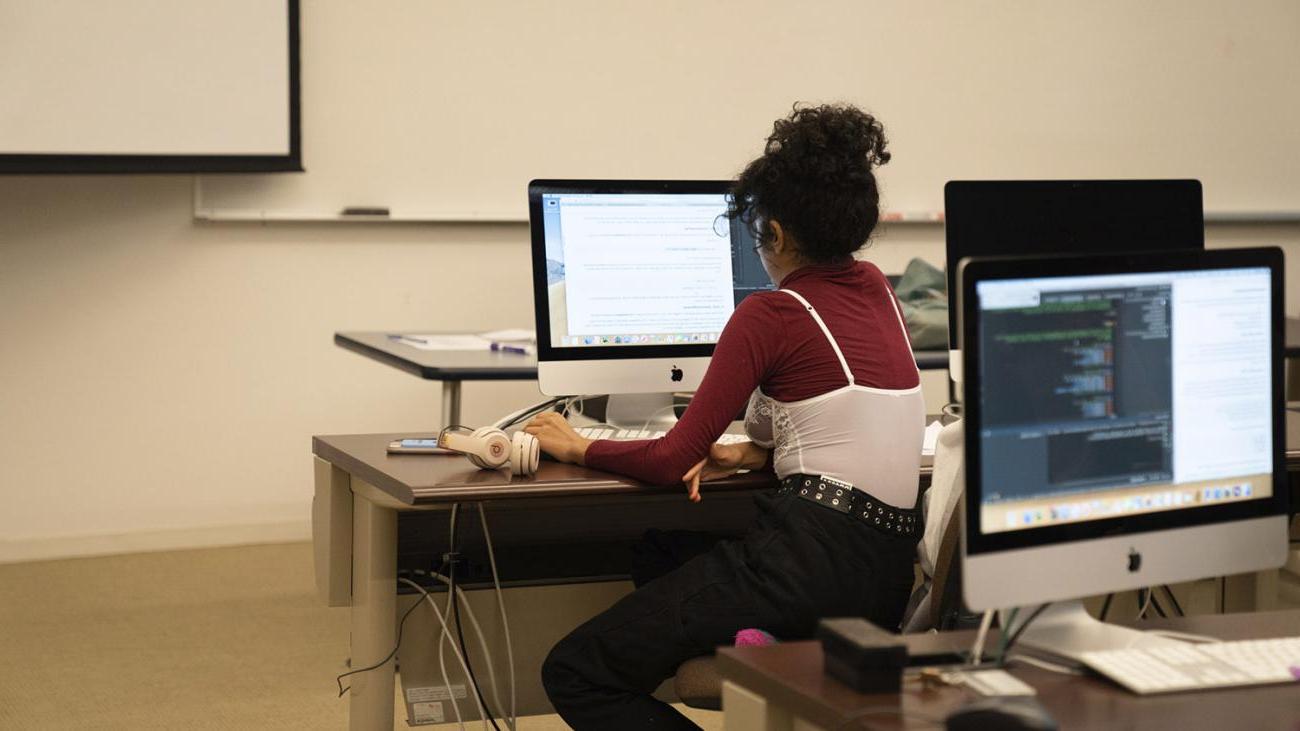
[944,179,1205,347]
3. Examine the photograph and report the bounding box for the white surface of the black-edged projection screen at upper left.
[0,0,291,156]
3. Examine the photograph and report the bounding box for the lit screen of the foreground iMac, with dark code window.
[976,268,1274,533]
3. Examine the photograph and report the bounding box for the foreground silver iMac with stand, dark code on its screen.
[958,248,1288,657]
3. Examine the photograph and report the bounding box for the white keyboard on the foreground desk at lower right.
[1083,637,1300,695]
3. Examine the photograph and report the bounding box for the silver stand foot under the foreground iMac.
[1013,600,1186,662]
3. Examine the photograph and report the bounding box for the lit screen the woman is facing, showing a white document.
[541,193,772,347]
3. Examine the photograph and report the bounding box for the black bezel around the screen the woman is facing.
[528,179,735,362]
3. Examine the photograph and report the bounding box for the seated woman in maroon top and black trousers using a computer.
[527,105,924,730]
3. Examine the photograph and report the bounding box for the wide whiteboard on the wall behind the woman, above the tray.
[195,0,1300,220]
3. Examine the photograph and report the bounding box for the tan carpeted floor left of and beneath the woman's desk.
[0,544,722,731]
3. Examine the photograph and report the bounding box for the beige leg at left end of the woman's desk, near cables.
[348,494,398,730]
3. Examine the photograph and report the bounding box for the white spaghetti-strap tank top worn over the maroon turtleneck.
[745,289,926,509]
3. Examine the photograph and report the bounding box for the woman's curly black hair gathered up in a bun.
[729,104,891,263]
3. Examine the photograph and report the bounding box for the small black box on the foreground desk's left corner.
[816,617,907,693]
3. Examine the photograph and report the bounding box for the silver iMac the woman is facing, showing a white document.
[528,179,772,418]
